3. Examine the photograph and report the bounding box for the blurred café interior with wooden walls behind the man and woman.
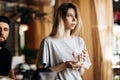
[0,0,120,80]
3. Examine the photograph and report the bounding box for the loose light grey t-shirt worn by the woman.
[38,36,91,80]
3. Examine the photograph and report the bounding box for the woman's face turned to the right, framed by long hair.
[65,8,77,30]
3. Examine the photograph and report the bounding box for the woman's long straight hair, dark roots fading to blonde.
[50,3,83,38]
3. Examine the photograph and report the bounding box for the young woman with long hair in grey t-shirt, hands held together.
[38,3,91,80]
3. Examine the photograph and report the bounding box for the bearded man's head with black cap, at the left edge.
[0,16,10,47]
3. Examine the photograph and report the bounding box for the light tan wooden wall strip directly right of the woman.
[79,0,94,80]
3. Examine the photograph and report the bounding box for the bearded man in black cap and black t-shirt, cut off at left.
[0,16,15,79]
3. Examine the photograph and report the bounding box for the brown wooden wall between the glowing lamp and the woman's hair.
[25,5,53,50]
